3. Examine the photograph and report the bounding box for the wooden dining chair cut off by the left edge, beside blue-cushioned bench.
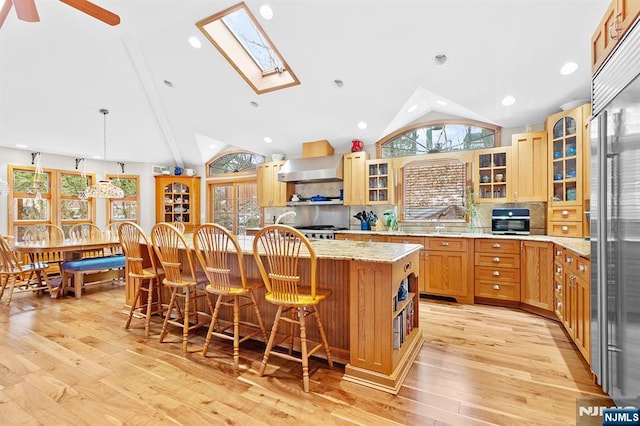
[0,235,52,304]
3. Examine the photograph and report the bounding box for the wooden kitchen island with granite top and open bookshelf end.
[137,236,423,394]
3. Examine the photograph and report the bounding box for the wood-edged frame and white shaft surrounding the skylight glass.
[196,2,300,95]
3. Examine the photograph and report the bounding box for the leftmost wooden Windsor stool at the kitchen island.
[117,222,164,337]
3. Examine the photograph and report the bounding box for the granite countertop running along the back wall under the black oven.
[340,230,591,257]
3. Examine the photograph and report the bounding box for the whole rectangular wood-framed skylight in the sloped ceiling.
[196,3,300,94]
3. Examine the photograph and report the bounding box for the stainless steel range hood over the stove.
[278,155,343,183]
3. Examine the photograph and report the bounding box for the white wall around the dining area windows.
[0,147,162,235]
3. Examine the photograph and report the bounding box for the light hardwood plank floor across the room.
[0,285,602,425]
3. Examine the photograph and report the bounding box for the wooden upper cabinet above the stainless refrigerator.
[591,0,640,73]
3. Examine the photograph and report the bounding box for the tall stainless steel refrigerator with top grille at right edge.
[590,16,640,407]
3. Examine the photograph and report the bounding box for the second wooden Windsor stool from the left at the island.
[151,222,208,353]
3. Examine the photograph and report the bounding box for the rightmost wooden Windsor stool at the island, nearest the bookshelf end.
[253,225,333,392]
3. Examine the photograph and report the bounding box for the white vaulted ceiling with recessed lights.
[0,0,610,166]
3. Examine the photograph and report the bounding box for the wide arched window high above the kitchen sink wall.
[376,120,500,158]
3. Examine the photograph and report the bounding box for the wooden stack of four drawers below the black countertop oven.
[474,238,520,302]
